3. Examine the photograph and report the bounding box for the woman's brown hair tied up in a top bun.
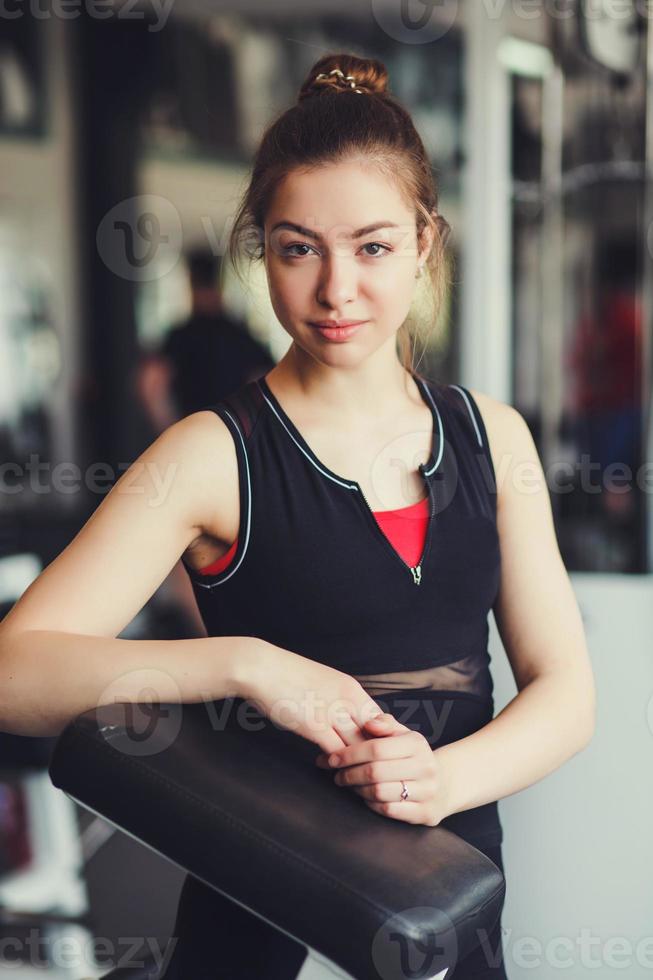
[228,53,451,371]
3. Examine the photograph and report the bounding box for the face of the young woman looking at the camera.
[265,162,420,365]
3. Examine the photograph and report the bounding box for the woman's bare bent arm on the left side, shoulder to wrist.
[0,411,265,736]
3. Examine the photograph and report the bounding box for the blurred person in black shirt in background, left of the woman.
[137,248,275,434]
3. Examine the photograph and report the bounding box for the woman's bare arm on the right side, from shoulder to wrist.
[435,389,596,813]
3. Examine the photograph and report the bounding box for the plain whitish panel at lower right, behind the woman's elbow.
[490,574,653,980]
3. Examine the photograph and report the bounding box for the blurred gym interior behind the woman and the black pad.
[0,0,653,980]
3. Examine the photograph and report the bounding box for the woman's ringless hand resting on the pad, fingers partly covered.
[240,641,383,754]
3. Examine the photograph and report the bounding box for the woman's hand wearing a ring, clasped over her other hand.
[315,713,449,827]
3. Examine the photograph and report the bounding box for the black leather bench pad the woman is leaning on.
[49,697,505,980]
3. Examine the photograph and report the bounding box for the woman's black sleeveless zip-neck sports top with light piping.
[182,374,502,843]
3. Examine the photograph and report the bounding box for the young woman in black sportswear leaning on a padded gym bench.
[0,54,594,980]
